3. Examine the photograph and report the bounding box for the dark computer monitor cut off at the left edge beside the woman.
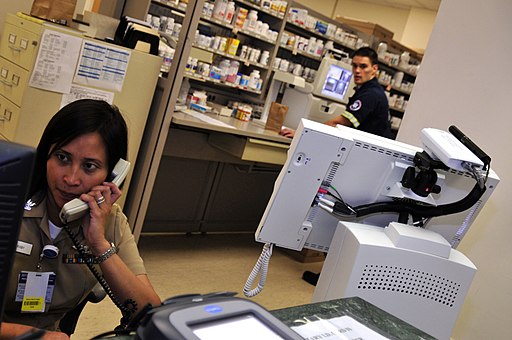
[0,141,35,330]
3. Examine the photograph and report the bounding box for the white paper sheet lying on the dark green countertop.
[291,315,388,340]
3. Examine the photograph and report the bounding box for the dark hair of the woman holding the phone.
[28,99,128,197]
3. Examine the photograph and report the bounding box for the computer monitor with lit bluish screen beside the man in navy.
[313,57,355,104]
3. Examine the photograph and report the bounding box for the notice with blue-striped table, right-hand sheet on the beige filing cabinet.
[74,40,131,92]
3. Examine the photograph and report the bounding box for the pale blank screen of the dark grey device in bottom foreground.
[191,314,283,340]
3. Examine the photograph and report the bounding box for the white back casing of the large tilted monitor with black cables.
[256,119,499,252]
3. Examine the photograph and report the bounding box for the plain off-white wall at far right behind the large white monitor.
[398,0,512,340]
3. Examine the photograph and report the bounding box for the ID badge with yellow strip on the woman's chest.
[15,271,55,313]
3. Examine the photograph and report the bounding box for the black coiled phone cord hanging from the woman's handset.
[64,224,137,329]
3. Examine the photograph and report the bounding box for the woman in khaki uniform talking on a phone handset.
[1,99,161,336]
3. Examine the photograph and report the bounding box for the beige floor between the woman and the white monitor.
[72,233,322,340]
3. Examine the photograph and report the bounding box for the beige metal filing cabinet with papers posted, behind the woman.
[0,14,160,203]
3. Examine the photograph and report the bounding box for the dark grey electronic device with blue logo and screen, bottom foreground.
[137,292,302,340]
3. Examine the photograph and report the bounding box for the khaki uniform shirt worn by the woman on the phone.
[3,200,146,330]
